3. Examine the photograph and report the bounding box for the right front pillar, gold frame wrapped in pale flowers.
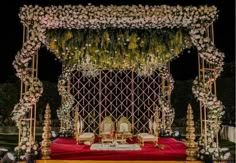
[190,24,227,160]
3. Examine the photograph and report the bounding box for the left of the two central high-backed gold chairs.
[99,116,115,143]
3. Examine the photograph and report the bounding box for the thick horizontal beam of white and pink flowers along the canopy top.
[19,4,217,29]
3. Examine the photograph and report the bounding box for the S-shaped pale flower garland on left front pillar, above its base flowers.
[12,26,43,124]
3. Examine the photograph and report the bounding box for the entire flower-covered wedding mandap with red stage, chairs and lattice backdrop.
[12,4,228,162]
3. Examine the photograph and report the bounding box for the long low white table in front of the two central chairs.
[90,143,141,151]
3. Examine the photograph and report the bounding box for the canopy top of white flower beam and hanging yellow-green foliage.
[16,5,222,74]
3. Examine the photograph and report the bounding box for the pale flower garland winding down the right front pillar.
[190,27,229,160]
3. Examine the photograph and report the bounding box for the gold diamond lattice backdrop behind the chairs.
[69,70,169,134]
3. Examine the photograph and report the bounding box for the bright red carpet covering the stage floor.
[51,138,186,161]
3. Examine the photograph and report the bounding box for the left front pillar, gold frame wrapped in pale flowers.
[12,22,43,159]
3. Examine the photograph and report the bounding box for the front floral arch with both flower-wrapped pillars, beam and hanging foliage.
[12,4,227,159]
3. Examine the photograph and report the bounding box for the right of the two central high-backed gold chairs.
[116,117,133,139]
